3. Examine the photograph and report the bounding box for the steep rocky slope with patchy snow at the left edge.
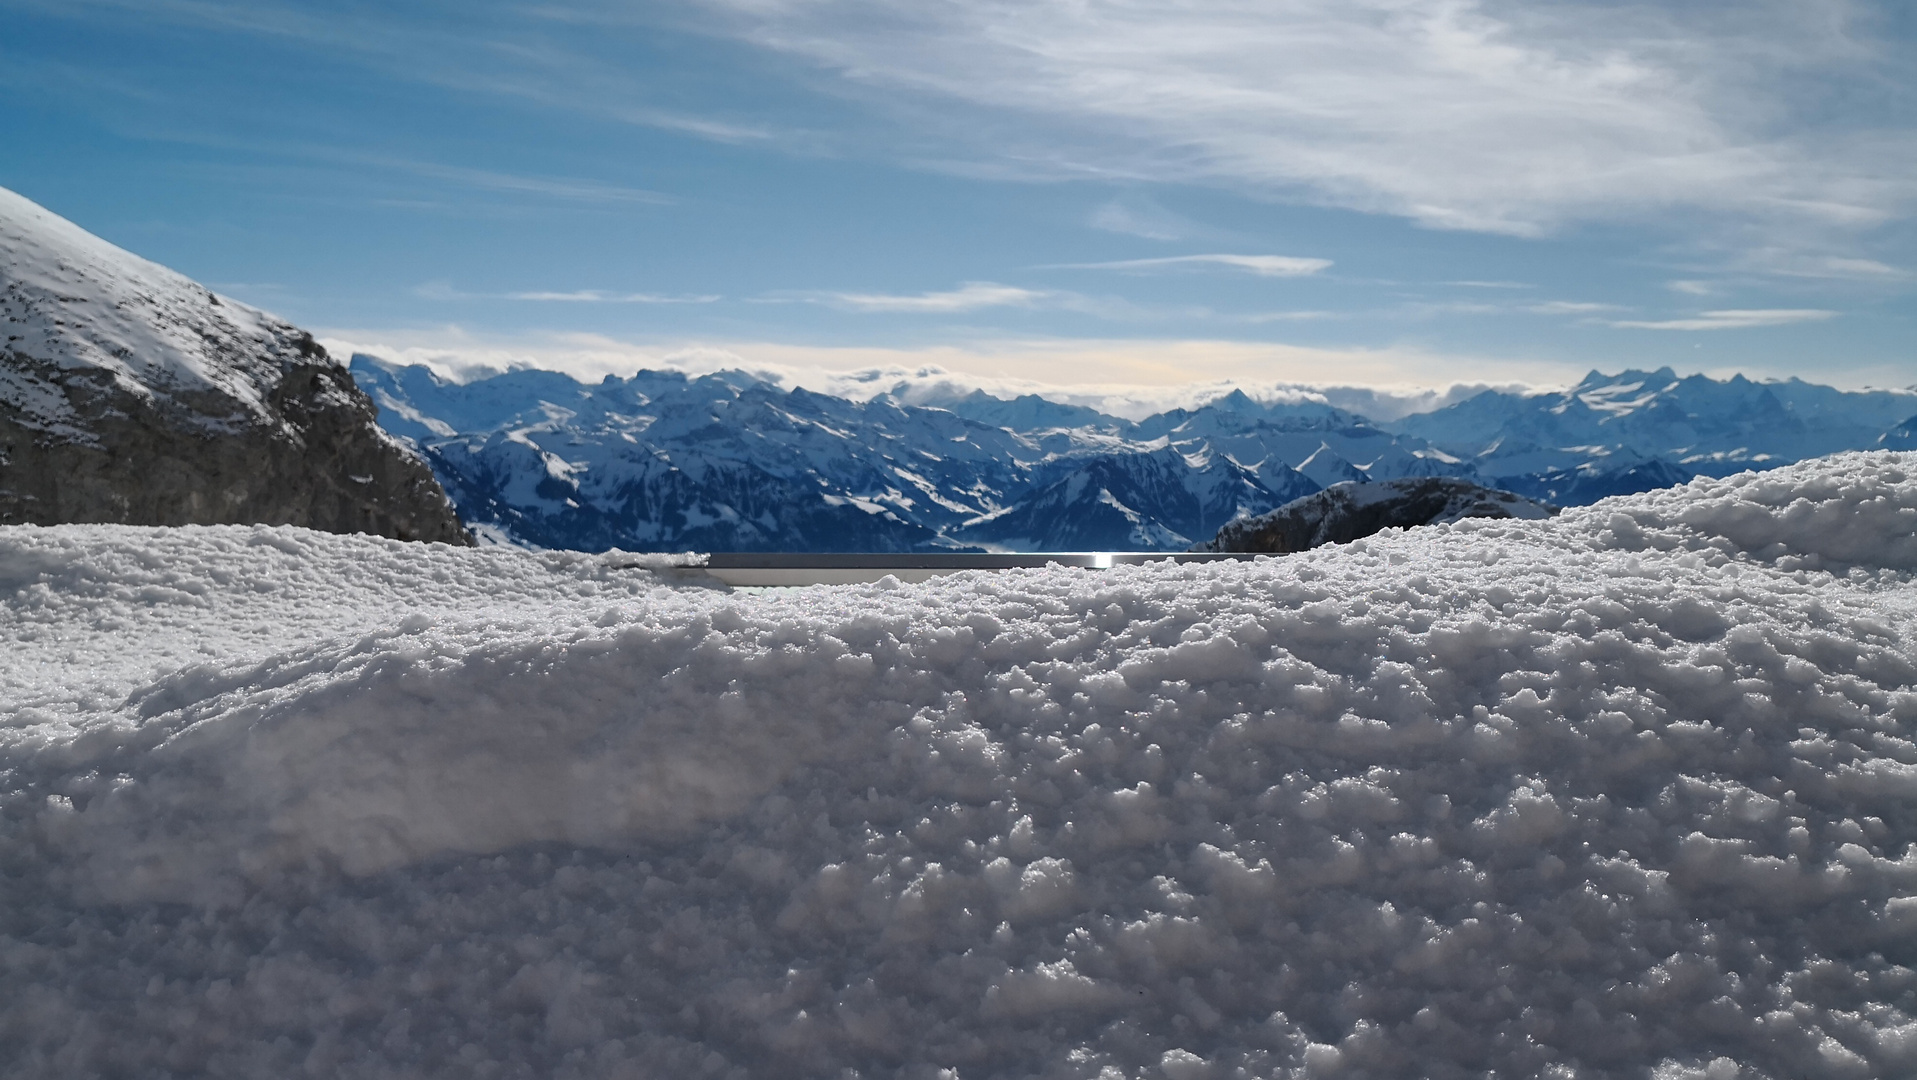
[0,190,472,545]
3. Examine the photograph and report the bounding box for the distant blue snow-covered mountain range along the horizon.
[353,355,1917,551]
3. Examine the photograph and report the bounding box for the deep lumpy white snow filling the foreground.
[0,455,1917,1080]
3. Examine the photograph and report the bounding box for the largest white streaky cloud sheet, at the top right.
[707,0,1917,236]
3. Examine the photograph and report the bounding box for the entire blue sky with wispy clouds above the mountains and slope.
[0,0,1917,397]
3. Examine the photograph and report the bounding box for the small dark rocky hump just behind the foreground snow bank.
[1192,476,1559,554]
